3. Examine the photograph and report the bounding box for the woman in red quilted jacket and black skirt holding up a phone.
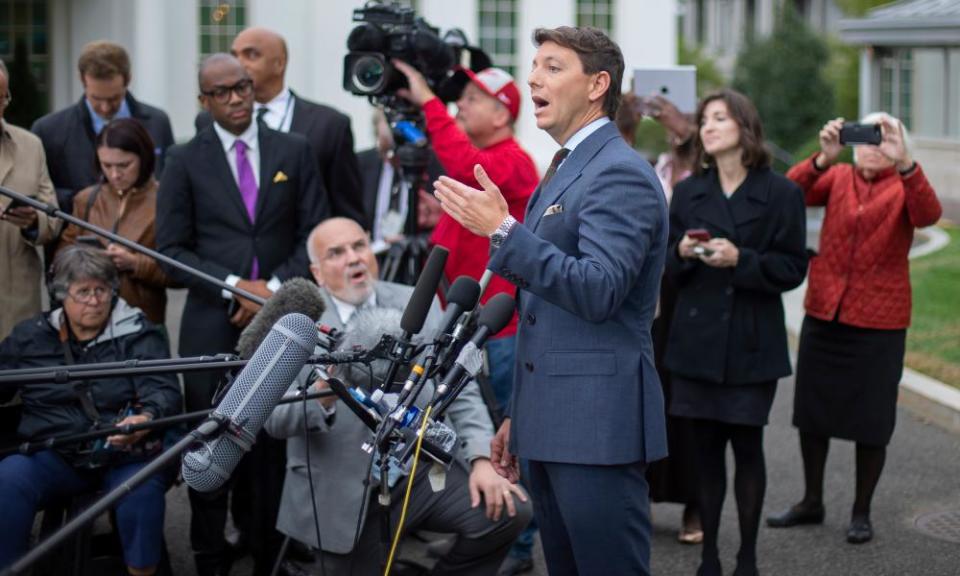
[767,113,941,544]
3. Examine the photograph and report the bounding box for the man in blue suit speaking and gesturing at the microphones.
[435,27,668,576]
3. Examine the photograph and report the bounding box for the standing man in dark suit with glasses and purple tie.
[157,54,328,575]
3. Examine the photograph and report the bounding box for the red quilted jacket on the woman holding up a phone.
[787,158,942,330]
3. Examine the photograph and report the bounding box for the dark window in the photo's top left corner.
[0,0,50,126]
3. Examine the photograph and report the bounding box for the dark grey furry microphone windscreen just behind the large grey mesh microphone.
[237,278,326,358]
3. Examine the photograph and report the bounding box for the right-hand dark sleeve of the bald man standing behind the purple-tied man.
[318,117,370,230]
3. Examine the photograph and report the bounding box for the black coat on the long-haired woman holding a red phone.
[665,168,807,384]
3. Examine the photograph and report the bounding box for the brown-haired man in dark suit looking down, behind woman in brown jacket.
[32,41,173,212]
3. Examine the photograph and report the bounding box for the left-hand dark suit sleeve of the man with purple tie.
[157,147,231,298]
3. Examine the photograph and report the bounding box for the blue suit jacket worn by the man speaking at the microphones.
[489,122,668,465]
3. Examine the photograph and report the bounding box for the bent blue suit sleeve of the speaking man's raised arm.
[489,162,665,323]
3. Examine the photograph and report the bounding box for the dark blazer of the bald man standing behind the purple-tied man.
[194,90,370,230]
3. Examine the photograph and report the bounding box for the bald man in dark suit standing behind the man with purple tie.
[196,27,370,230]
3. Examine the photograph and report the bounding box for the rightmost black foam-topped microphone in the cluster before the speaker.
[434,292,517,417]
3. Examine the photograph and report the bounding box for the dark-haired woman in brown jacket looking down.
[59,118,167,325]
